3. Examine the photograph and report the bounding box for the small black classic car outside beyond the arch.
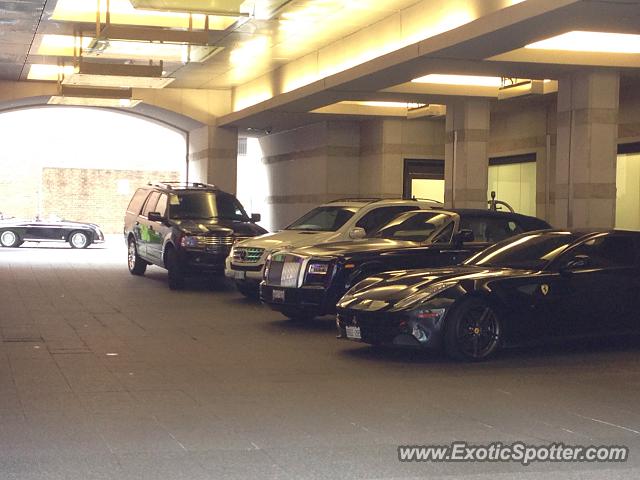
[0,218,104,248]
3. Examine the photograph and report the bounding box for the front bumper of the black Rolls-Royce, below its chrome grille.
[260,282,335,315]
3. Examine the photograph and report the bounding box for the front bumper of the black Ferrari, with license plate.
[336,309,444,350]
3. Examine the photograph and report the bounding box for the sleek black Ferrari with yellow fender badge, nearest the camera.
[337,230,640,360]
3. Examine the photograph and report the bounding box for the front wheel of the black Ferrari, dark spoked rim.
[445,298,502,361]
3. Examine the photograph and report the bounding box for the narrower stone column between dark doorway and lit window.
[444,98,489,208]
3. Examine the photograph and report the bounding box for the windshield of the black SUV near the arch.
[169,192,249,222]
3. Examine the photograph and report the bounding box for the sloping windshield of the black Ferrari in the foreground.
[464,232,578,270]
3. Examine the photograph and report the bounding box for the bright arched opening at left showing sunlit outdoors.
[0,106,188,233]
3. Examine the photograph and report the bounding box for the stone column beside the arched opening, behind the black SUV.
[189,126,238,194]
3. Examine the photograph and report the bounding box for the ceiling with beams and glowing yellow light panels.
[0,0,640,130]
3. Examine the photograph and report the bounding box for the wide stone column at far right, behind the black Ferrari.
[553,71,620,228]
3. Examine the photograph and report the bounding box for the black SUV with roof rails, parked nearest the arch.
[124,182,267,290]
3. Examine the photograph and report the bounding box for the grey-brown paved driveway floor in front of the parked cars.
[0,238,640,480]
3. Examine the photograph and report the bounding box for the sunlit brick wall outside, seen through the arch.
[42,167,180,233]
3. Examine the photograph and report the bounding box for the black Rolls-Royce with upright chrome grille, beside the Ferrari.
[260,209,550,319]
